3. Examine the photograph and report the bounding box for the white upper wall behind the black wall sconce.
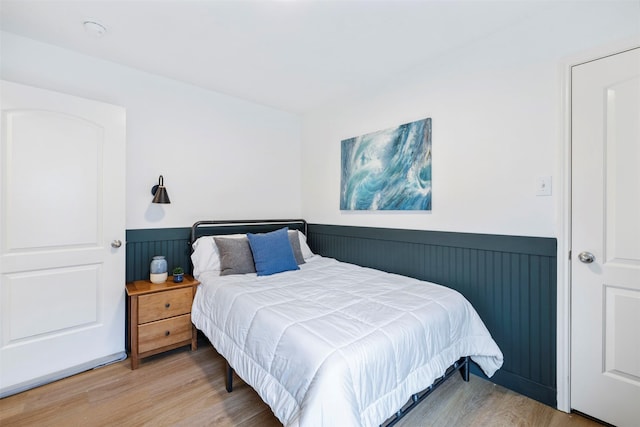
[0,32,301,229]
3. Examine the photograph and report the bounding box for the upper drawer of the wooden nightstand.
[138,288,193,324]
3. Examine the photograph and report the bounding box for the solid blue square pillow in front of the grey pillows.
[247,227,300,276]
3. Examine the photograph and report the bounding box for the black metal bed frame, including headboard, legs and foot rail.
[189,219,470,427]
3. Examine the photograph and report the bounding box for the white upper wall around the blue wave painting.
[302,1,640,237]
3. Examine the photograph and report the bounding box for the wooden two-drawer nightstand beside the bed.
[127,274,200,369]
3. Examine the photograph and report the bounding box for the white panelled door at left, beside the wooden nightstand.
[0,81,126,396]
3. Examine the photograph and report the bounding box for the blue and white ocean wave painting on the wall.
[340,118,431,210]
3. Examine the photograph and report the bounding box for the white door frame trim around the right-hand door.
[556,37,640,412]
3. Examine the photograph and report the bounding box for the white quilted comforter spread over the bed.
[191,256,502,427]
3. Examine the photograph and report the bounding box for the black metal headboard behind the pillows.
[190,219,307,243]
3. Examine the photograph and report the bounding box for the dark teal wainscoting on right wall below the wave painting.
[309,224,557,407]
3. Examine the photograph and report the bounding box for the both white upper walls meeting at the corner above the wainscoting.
[0,1,640,237]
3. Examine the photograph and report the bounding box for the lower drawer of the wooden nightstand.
[138,314,192,353]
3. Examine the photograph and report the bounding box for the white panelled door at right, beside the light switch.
[571,48,640,427]
